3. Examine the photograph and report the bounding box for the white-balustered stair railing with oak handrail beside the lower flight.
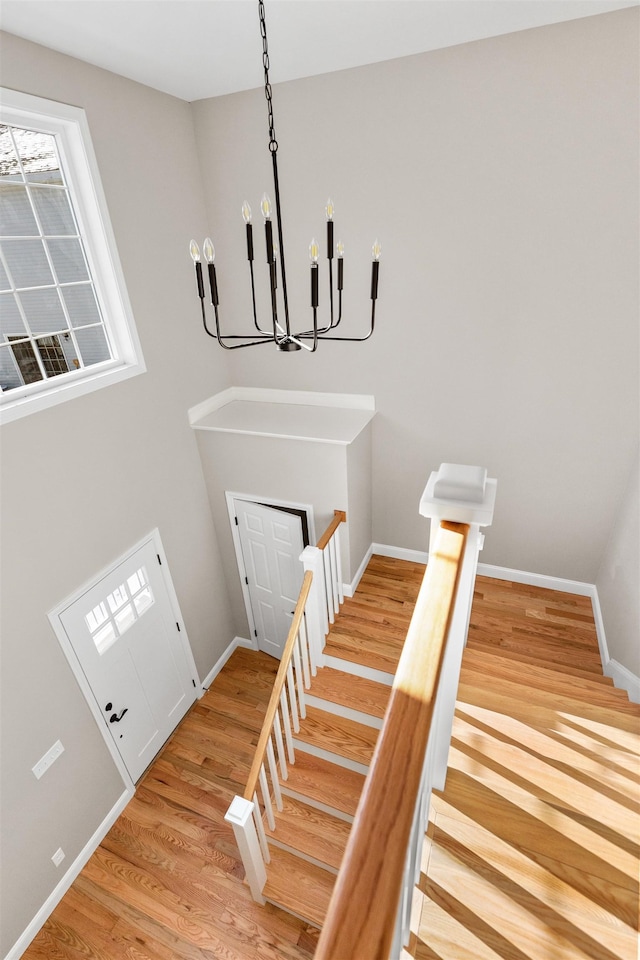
[225,510,347,904]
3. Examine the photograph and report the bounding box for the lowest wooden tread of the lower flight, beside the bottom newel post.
[262,847,336,927]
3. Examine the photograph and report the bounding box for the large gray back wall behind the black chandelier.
[194,9,639,582]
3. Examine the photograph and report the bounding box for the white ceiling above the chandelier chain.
[0,0,640,100]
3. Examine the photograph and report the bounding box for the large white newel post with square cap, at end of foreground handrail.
[420,463,498,790]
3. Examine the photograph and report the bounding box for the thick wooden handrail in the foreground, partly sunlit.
[315,521,469,960]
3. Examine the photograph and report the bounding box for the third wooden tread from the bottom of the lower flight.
[282,750,365,817]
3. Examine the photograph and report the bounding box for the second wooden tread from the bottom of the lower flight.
[265,796,351,871]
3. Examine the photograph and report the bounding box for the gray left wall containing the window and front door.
[0,35,233,956]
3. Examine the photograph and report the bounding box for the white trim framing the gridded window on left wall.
[0,87,146,423]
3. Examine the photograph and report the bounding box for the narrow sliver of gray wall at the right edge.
[596,457,640,677]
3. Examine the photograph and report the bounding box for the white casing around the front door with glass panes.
[48,528,200,795]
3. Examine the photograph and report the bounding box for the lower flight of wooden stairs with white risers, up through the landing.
[255,556,425,927]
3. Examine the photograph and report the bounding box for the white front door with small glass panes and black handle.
[59,540,196,783]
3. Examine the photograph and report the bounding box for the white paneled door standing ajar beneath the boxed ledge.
[235,500,304,659]
